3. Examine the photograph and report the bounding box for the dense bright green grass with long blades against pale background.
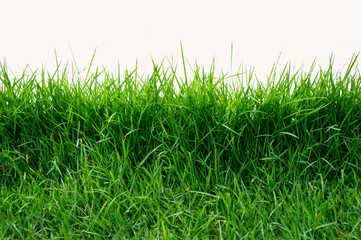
[0,56,361,239]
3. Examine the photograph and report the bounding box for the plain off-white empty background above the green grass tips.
[0,0,361,86]
